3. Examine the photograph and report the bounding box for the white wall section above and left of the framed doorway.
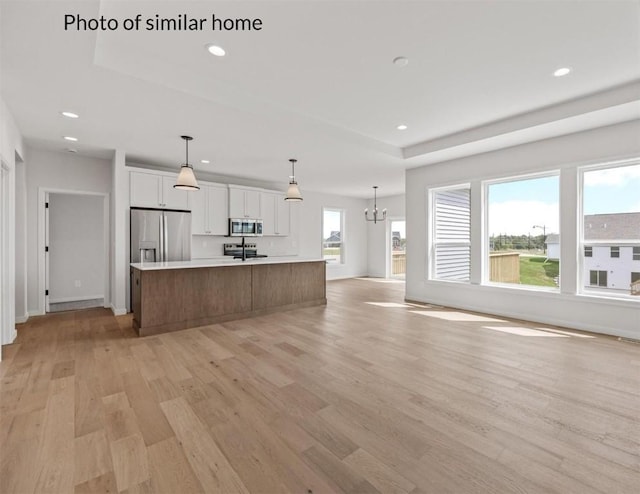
[25,147,111,315]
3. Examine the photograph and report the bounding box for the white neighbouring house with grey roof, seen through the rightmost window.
[583,213,640,293]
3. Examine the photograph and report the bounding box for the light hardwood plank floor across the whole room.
[0,280,640,494]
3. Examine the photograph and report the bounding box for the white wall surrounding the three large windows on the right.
[406,120,640,338]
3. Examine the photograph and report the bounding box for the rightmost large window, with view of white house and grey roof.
[581,164,640,298]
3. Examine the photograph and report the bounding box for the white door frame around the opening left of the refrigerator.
[38,187,111,315]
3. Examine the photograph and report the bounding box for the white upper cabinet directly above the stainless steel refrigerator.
[129,172,190,210]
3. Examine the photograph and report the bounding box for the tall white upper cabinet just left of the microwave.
[191,182,229,235]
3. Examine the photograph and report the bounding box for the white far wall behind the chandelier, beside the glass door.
[362,194,410,278]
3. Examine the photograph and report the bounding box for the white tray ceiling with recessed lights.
[0,0,640,197]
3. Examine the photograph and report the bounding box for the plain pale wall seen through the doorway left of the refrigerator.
[49,194,105,303]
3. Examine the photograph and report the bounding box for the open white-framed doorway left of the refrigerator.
[42,191,109,312]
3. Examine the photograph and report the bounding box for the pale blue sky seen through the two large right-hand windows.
[489,165,640,235]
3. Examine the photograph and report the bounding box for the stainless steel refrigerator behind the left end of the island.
[131,208,191,262]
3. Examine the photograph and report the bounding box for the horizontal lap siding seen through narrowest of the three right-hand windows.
[434,188,471,281]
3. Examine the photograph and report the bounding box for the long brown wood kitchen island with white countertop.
[131,257,327,336]
